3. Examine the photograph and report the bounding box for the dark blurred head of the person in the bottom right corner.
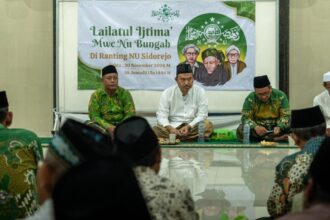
[309,137,330,203]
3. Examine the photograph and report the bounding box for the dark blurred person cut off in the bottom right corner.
[280,137,330,220]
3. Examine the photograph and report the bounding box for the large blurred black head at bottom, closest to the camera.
[53,157,150,220]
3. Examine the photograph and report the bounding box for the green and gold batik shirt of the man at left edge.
[0,124,42,220]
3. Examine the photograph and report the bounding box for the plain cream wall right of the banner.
[289,0,330,109]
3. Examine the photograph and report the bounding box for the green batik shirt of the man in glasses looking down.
[241,88,290,131]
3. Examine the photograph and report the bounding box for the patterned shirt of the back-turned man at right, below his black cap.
[267,137,324,217]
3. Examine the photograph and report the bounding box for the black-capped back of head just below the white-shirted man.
[114,116,160,166]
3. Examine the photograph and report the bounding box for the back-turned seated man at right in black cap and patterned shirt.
[267,106,326,217]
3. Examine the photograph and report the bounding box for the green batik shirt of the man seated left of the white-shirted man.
[88,87,135,129]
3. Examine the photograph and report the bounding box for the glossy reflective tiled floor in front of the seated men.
[162,148,293,219]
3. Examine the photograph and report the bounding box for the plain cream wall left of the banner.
[0,0,53,136]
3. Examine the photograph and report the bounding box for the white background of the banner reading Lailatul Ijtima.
[78,1,255,90]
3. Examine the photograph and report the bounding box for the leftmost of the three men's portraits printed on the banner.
[182,44,203,76]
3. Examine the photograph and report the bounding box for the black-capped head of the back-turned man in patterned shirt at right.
[290,106,326,141]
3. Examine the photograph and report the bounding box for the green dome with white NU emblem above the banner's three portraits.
[177,13,247,61]
